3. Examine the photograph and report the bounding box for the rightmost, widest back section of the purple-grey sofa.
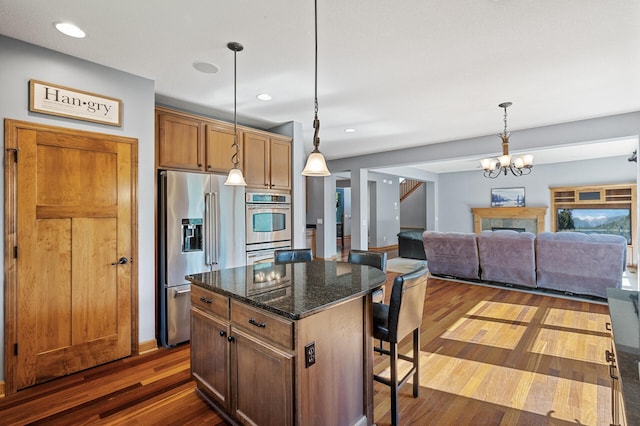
[536,232,627,297]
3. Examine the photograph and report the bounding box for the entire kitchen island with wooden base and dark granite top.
[187,260,386,425]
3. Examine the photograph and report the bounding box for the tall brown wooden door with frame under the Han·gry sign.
[5,120,137,392]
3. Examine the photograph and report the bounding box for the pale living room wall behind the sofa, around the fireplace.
[437,156,637,232]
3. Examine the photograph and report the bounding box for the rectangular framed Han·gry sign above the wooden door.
[29,80,122,127]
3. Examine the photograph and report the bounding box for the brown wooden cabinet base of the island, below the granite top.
[191,285,373,426]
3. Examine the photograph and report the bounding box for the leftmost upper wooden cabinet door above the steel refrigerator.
[158,114,204,170]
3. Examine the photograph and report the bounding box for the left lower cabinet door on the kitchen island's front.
[191,308,230,410]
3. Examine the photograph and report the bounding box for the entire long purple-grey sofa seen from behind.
[422,230,627,298]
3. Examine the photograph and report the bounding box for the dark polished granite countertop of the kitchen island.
[186,260,386,320]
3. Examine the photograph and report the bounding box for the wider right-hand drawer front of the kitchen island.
[231,300,294,349]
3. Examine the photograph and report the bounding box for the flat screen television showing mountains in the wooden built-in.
[556,208,631,244]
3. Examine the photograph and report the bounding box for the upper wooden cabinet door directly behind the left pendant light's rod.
[206,124,242,173]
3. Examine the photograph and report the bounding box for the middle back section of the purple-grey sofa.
[478,230,536,287]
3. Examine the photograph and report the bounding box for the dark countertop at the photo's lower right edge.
[607,288,640,425]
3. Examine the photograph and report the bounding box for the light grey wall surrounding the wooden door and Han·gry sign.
[0,36,155,380]
